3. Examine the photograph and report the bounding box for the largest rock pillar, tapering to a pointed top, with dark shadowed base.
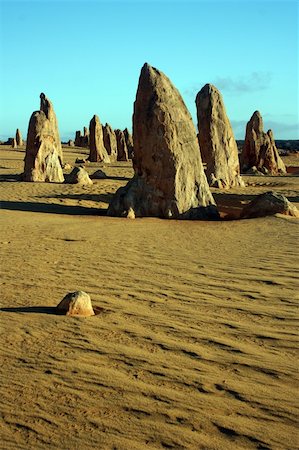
[108,64,219,219]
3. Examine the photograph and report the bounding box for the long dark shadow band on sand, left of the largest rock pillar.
[0,201,107,216]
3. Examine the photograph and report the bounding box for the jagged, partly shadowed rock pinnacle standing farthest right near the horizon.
[240,111,286,175]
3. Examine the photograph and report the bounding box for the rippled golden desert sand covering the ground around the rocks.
[0,146,299,450]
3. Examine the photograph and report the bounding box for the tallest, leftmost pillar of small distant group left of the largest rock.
[88,115,110,163]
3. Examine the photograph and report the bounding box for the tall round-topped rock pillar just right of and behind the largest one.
[196,84,245,188]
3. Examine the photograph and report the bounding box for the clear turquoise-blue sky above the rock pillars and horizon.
[0,0,299,140]
